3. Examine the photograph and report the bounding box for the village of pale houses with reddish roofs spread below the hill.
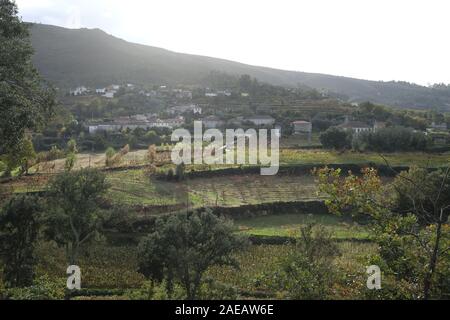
[63,83,449,151]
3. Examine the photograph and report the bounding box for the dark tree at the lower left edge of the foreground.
[0,196,42,287]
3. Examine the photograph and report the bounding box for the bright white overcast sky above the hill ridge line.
[16,0,450,85]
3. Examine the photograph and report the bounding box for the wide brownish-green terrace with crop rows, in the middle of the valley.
[108,170,317,207]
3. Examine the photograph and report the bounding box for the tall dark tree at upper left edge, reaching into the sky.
[0,0,55,154]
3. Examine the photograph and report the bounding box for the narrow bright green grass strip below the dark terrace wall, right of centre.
[235,214,369,239]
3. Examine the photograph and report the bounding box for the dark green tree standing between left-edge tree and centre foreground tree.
[46,169,109,264]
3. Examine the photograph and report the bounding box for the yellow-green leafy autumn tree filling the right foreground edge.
[317,168,450,299]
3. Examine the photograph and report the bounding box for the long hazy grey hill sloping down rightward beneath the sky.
[32,24,450,109]
